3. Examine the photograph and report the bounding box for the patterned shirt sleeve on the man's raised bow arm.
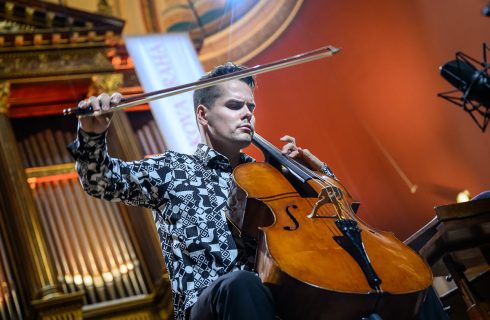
[68,128,170,208]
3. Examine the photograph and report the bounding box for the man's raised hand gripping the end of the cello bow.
[78,92,122,134]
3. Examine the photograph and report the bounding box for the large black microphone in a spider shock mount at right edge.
[438,43,490,132]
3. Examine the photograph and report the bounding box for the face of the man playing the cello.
[206,80,255,149]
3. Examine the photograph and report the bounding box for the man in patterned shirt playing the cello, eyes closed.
[70,63,332,319]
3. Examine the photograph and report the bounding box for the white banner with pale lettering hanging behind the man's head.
[125,33,204,154]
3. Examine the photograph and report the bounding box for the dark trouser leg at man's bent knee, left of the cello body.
[190,271,274,320]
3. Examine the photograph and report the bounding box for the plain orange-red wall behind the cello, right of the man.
[247,0,490,239]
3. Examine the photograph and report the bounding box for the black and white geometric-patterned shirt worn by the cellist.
[69,129,254,319]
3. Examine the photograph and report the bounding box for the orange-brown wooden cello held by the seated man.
[229,133,432,320]
